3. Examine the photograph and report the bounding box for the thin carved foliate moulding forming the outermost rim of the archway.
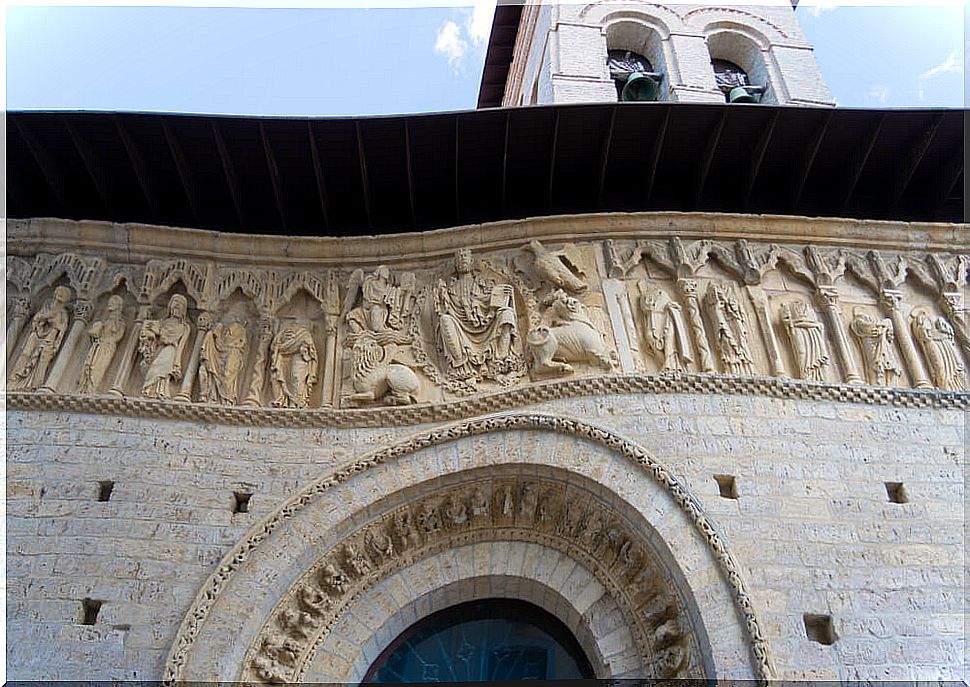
[163,413,773,685]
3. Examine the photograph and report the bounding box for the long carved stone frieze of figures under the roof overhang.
[7,231,970,410]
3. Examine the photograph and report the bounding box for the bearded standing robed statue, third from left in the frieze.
[138,294,191,398]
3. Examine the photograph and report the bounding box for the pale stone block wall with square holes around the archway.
[7,394,967,680]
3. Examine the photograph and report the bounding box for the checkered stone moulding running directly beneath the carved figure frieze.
[6,373,970,427]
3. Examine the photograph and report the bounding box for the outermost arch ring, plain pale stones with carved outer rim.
[164,414,771,683]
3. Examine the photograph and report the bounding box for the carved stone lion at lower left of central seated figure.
[344,331,421,406]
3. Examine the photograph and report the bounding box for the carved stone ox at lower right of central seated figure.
[526,289,616,375]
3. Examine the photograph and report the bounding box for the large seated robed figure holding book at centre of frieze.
[433,248,518,386]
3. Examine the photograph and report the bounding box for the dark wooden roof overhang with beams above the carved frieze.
[7,103,966,236]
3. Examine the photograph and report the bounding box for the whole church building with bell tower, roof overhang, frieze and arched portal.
[6,2,970,684]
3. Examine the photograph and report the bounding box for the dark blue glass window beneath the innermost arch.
[364,599,593,683]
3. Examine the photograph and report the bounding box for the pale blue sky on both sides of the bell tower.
[6,0,966,115]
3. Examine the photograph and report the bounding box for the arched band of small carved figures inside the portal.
[240,478,705,683]
